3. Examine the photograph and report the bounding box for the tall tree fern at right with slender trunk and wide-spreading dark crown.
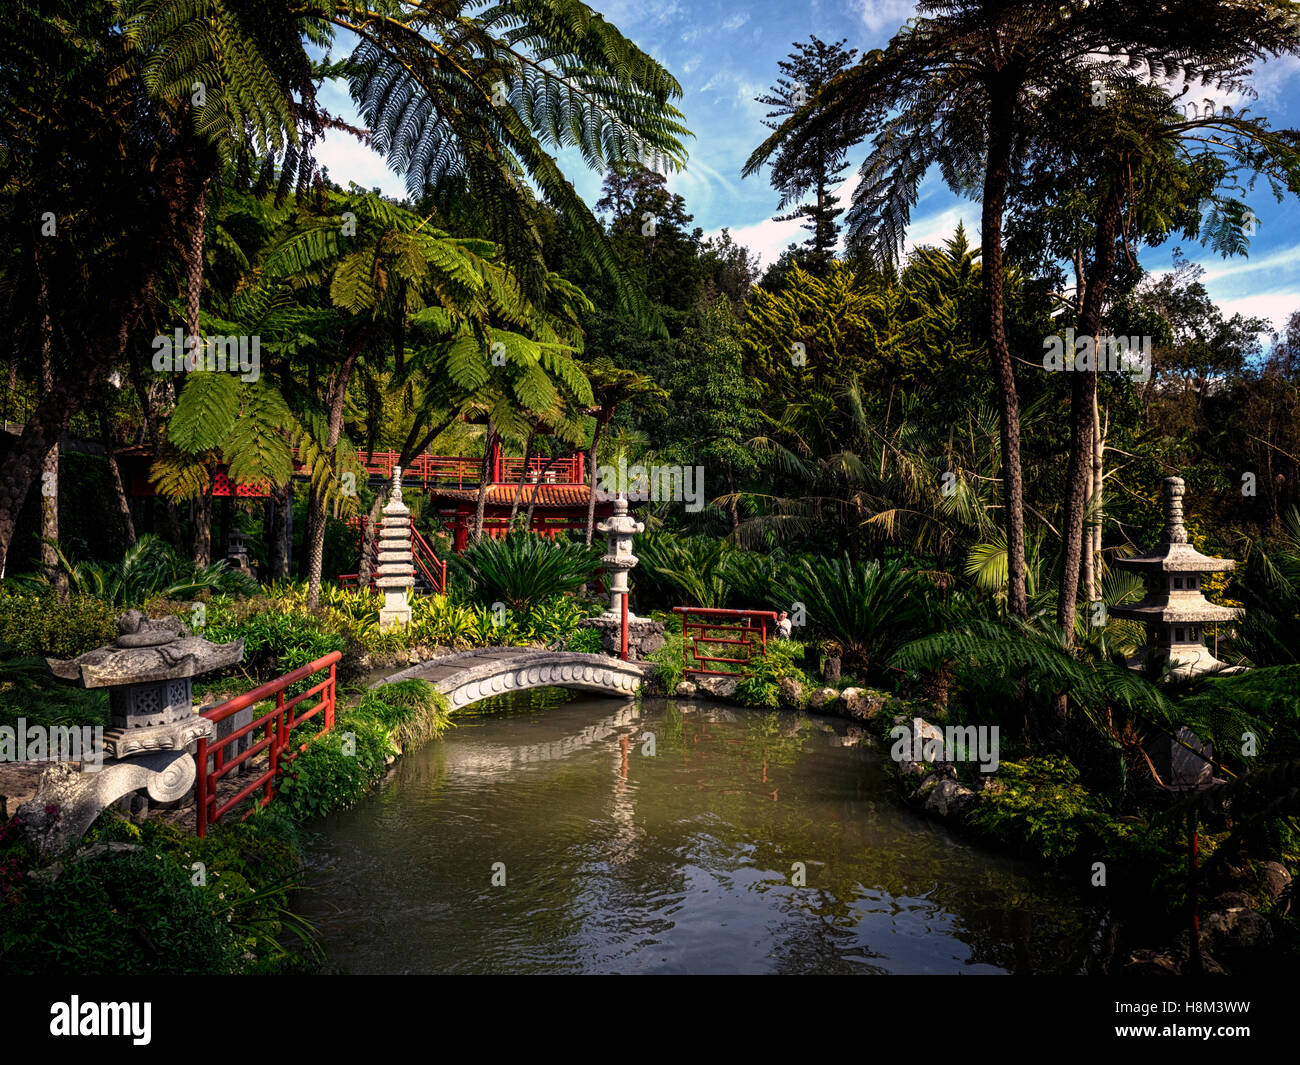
[745,0,1300,616]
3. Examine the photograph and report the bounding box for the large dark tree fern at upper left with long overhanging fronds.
[0,0,686,569]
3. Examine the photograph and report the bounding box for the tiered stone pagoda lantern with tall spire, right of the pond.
[1110,477,1242,677]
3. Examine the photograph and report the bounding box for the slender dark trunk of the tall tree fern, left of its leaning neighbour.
[980,92,1030,618]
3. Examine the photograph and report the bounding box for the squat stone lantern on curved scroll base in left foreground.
[18,610,243,854]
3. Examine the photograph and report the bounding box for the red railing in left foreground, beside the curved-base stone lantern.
[194,651,342,836]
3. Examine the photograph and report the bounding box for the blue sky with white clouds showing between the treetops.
[317,0,1300,328]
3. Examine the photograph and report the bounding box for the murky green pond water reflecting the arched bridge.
[296,689,1102,973]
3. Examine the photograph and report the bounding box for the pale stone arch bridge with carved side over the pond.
[376,648,651,710]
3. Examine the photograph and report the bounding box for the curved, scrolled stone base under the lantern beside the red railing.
[16,750,195,857]
